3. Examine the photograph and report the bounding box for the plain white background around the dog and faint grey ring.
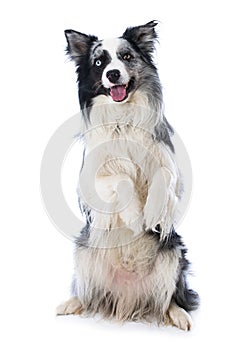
[0,0,233,350]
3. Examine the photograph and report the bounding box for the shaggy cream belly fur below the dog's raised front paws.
[75,234,179,320]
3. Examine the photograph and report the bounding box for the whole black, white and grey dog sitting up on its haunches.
[57,21,199,330]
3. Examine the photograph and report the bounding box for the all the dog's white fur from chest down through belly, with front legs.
[72,93,183,327]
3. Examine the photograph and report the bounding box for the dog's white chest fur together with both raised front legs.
[80,96,180,238]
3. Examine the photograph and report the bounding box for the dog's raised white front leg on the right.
[144,167,178,239]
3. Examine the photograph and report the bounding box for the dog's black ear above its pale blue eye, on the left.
[65,29,98,65]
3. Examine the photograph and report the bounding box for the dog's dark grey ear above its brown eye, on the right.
[122,21,158,54]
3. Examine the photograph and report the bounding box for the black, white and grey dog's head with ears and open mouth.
[65,21,157,108]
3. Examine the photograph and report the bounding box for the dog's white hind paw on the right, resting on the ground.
[167,303,192,331]
